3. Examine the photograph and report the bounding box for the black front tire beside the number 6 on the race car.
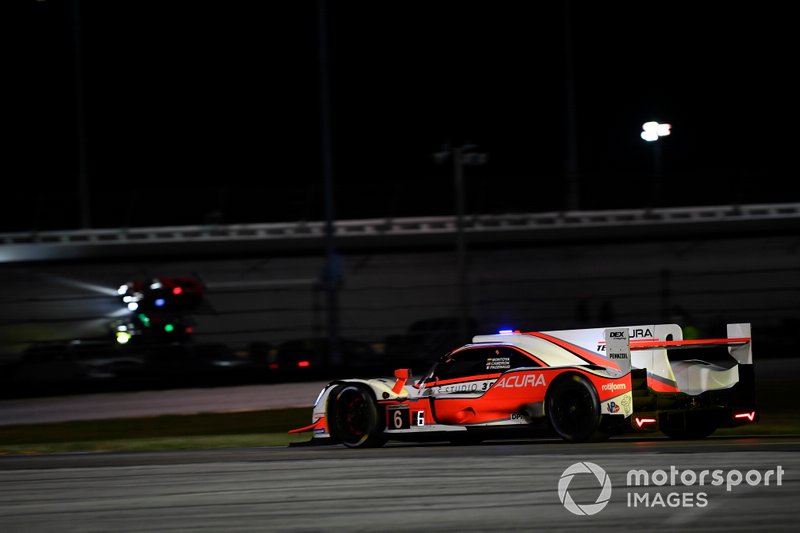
[329,385,387,448]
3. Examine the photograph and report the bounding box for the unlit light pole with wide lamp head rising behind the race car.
[433,144,488,340]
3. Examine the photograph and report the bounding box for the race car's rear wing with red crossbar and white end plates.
[604,323,753,372]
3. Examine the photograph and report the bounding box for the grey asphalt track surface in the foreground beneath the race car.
[0,437,800,533]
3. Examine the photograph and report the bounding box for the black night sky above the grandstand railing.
[0,0,800,232]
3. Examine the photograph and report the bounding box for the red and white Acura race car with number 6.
[290,323,758,448]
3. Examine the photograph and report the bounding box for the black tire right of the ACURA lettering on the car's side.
[545,374,608,442]
